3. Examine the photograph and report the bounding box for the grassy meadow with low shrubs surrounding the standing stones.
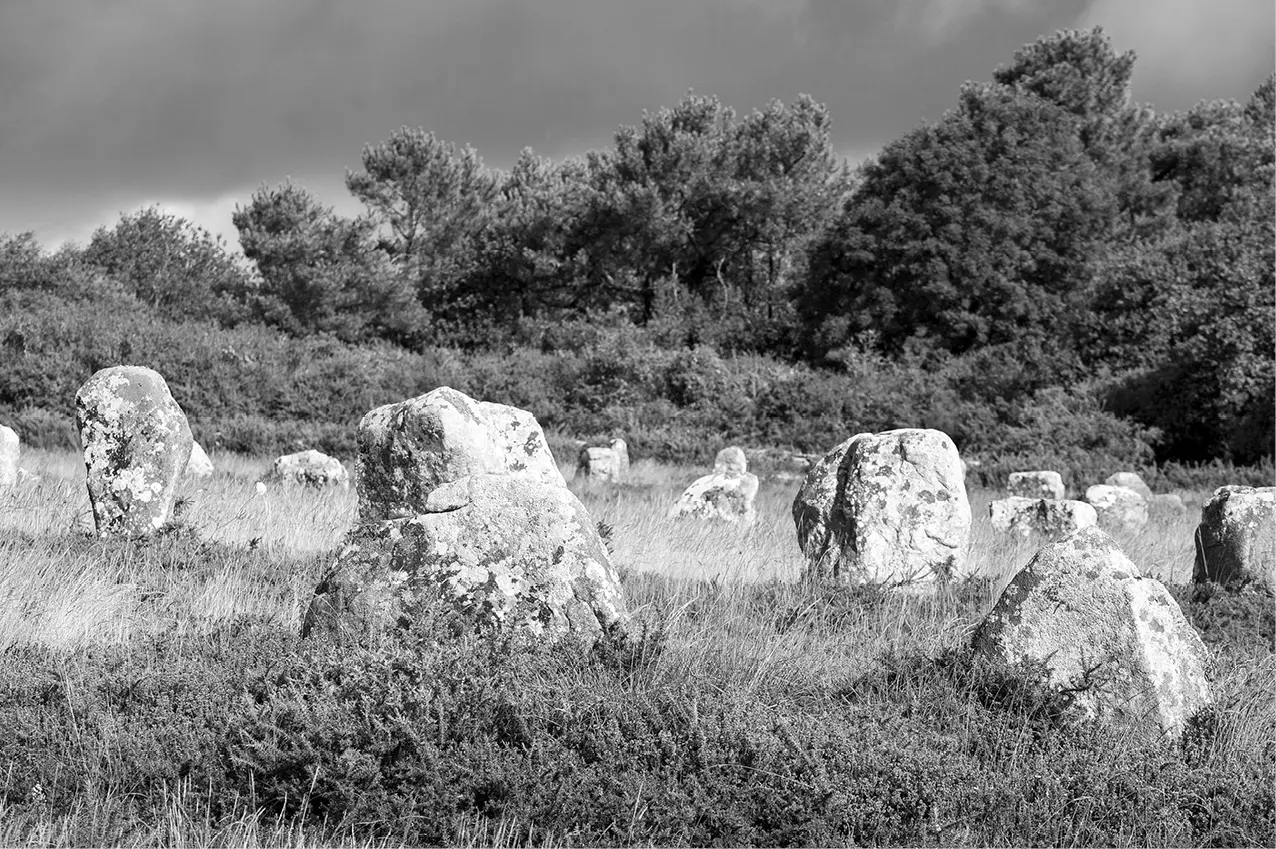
[0,449,1276,846]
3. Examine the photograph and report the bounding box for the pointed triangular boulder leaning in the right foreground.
[974,527,1212,735]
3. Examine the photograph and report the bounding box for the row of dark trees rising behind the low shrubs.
[0,28,1276,462]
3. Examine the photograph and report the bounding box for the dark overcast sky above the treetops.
[0,0,1276,248]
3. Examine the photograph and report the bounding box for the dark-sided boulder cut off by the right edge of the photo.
[1192,486,1276,595]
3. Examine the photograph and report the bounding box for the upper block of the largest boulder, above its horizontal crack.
[355,387,567,522]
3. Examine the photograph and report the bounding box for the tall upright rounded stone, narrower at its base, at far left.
[75,365,193,536]
